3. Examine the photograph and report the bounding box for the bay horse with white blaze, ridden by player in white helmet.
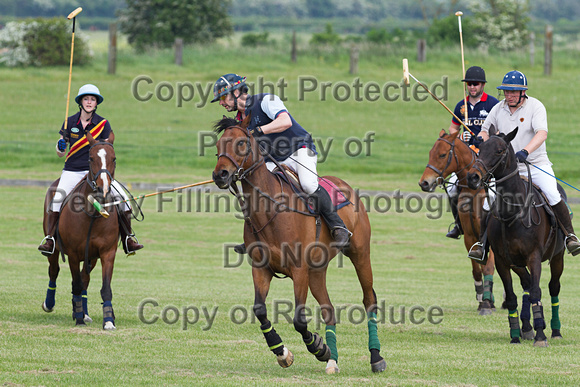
[42,133,119,330]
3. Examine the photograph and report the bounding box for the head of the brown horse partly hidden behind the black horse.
[419,129,461,192]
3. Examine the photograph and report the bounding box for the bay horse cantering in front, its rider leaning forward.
[213,117,386,374]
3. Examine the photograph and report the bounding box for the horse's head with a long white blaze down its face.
[87,132,116,197]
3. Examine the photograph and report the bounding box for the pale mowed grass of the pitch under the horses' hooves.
[0,187,580,386]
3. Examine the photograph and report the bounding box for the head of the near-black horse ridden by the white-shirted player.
[467,127,518,189]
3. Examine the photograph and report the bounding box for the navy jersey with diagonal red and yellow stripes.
[59,112,112,172]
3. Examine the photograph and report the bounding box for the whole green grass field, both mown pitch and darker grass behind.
[0,31,580,386]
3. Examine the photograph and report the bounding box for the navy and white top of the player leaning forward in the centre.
[237,94,316,161]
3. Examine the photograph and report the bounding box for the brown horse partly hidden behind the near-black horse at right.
[419,130,495,315]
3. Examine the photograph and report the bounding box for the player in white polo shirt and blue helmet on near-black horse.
[468,70,580,260]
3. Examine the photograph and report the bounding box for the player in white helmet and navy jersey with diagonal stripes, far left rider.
[38,84,143,256]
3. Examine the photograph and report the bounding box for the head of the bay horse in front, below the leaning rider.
[212,116,263,189]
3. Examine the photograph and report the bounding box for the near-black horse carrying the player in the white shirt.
[467,128,565,347]
